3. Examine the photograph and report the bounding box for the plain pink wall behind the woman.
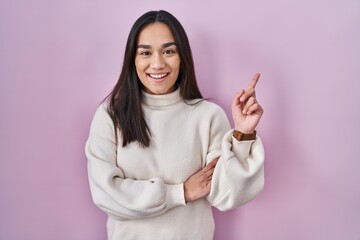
[0,0,360,240]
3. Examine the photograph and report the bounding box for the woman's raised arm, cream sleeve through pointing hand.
[207,74,265,211]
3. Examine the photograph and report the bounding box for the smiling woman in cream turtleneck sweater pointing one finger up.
[86,11,264,240]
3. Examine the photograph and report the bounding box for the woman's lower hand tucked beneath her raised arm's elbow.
[184,158,219,203]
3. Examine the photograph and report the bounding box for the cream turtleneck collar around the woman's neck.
[142,88,181,107]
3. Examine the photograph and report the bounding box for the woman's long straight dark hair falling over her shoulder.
[106,10,203,147]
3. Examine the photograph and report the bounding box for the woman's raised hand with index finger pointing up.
[231,73,264,134]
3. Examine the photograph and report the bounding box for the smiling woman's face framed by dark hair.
[135,23,180,95]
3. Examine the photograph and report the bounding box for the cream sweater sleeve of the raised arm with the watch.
[207,106,265,211]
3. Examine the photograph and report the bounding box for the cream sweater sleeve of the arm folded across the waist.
[85,105,185,219]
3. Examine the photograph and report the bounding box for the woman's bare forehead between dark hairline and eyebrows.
[138,22,175,45]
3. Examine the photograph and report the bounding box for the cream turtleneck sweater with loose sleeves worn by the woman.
[85,90,264,240]
